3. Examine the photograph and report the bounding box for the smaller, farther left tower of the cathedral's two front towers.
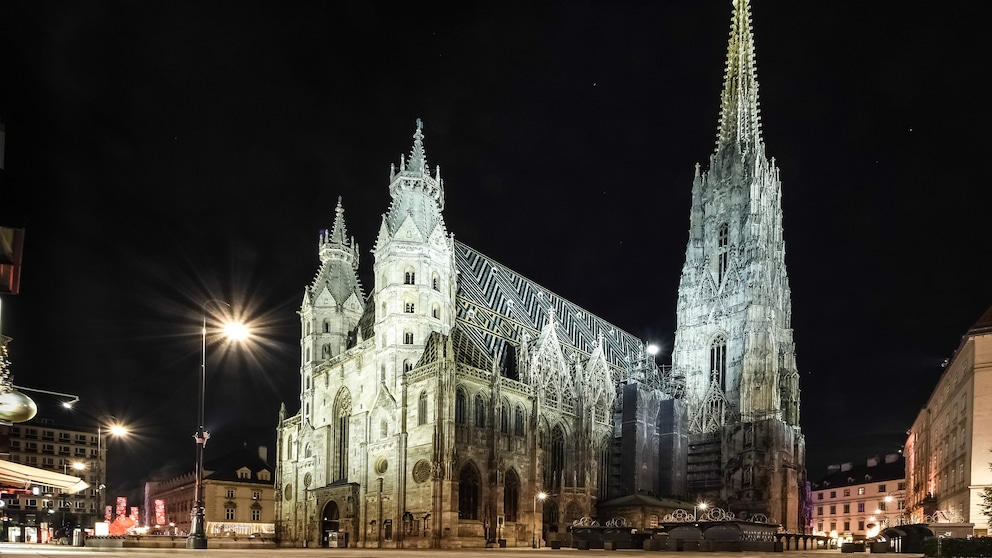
[299,198,365,420]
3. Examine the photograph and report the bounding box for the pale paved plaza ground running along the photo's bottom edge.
[0,543,923,558]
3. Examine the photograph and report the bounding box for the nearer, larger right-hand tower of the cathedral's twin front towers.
[373,119,456,386]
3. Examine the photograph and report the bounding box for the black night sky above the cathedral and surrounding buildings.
[0,0,992,498]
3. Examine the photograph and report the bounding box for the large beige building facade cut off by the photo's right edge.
[904,307,992,536]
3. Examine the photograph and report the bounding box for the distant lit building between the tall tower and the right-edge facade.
[812,454,909,542]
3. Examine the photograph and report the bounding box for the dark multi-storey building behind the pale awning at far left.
[0,420,107,542]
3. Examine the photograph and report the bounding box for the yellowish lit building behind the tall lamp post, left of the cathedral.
[143,446,275,538]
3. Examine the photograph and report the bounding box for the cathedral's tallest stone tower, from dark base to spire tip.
[672,0,805,532]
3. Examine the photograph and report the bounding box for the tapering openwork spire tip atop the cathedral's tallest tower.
[716,0,762,158]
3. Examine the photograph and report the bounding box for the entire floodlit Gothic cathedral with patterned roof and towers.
[276,0,806,548]
